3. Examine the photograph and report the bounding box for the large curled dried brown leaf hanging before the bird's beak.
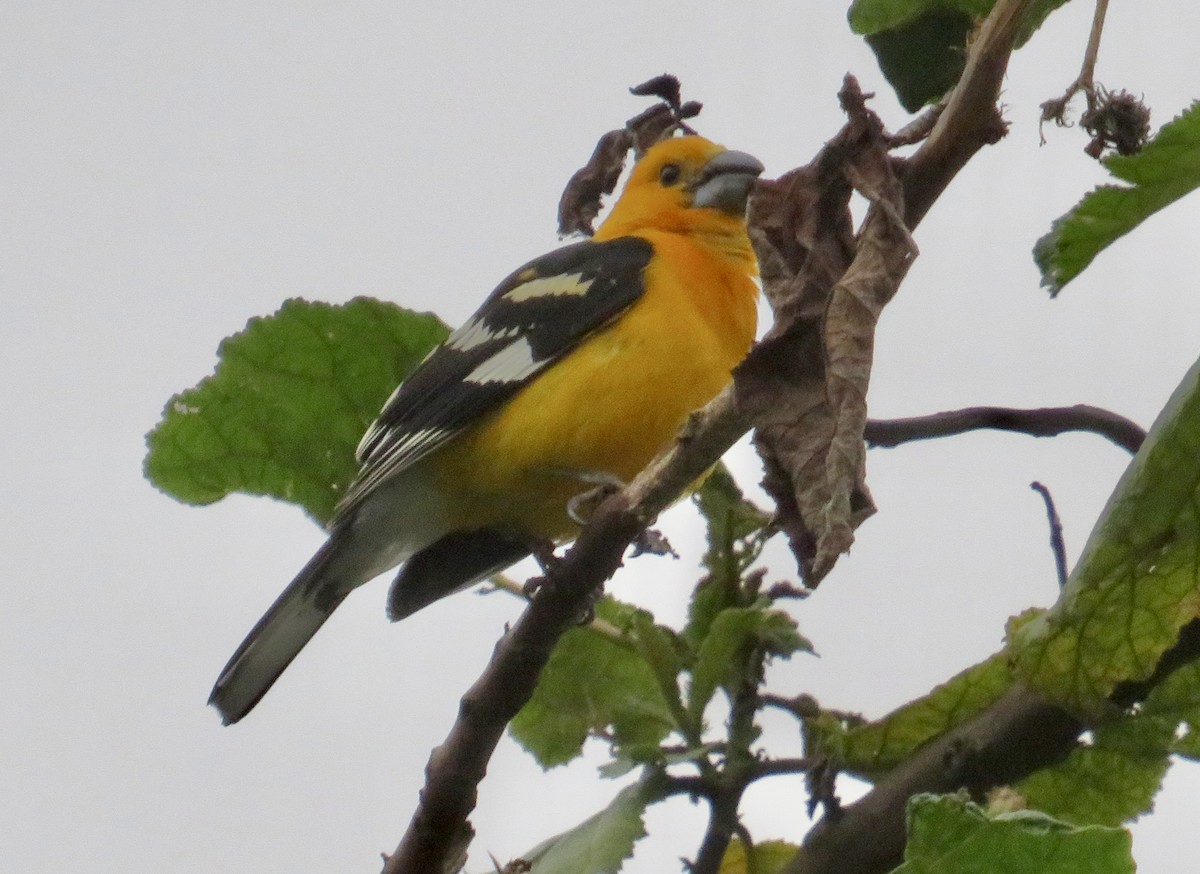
[737,77,914,586]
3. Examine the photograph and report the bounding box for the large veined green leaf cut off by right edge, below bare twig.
[1009,361,1200,716]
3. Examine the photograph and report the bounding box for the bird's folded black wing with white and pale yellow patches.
[338,237,654,515]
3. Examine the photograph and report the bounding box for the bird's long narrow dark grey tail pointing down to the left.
[209,529,358,725]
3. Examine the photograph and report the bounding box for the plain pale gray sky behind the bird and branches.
[0,0,1200,874]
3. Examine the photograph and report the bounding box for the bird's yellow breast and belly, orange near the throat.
[428,232,757,539]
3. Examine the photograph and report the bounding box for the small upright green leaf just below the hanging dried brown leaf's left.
[683,463,773,648]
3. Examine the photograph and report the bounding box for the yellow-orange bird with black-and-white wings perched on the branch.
[209,134,763,725]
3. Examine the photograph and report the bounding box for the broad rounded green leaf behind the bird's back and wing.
[145,298,448,521]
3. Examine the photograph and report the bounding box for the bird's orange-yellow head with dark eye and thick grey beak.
[595,137,763,240]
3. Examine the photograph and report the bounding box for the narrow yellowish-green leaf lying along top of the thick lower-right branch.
[804,653,1013,780]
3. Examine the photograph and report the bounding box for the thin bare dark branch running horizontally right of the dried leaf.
[864,403,1146,454]
